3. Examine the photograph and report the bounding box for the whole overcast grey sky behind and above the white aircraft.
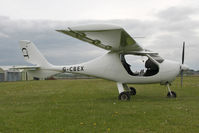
[0,0,199,70]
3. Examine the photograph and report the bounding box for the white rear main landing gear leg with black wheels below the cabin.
[117,83,136,101]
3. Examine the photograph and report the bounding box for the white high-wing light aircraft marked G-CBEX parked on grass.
[18,25,188,100]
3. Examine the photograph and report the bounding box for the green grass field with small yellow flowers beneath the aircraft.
[0,77,199,133]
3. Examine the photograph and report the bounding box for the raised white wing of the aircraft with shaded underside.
[56,25,145,53]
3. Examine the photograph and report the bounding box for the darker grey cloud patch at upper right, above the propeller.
[157,7,199,36]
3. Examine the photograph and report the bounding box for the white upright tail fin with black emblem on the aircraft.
[19,40,52,67]
